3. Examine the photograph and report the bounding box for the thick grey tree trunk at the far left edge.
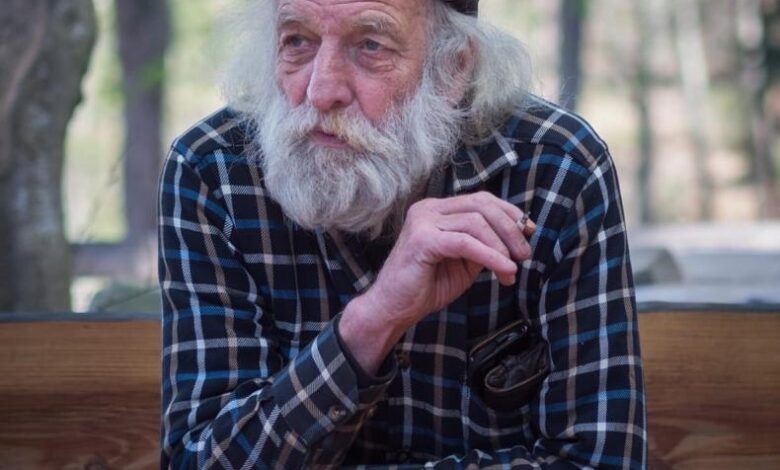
[0,0,96,311]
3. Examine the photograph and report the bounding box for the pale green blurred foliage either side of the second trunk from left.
[64,0,224,242]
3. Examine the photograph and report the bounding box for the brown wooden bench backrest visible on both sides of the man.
[0,307,780,470]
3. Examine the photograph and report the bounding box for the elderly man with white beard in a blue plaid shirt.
[160,0,646,468]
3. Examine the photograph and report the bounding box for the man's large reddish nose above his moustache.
[306,44,354,112]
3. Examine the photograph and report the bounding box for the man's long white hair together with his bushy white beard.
[223,0,528,238]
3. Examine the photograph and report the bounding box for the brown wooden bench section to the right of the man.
[640,312,780,469]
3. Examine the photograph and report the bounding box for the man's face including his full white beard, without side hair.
[258,0,461,236]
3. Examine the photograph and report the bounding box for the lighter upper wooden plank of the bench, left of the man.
[0,321,160,395]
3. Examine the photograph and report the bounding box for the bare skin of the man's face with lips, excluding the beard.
[276,0,426,140]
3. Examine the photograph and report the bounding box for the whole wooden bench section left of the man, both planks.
[0,321,160,470]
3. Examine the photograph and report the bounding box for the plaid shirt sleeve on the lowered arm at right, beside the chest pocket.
[354,154,647,470]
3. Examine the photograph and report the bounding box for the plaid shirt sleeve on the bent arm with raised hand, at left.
[159,147,389,469]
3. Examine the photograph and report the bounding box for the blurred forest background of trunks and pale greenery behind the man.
[0,0,780,311]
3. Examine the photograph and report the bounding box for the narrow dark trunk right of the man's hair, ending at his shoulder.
[558,0,586,110]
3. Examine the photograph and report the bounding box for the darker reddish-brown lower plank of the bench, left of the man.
[0,392,160,470]
